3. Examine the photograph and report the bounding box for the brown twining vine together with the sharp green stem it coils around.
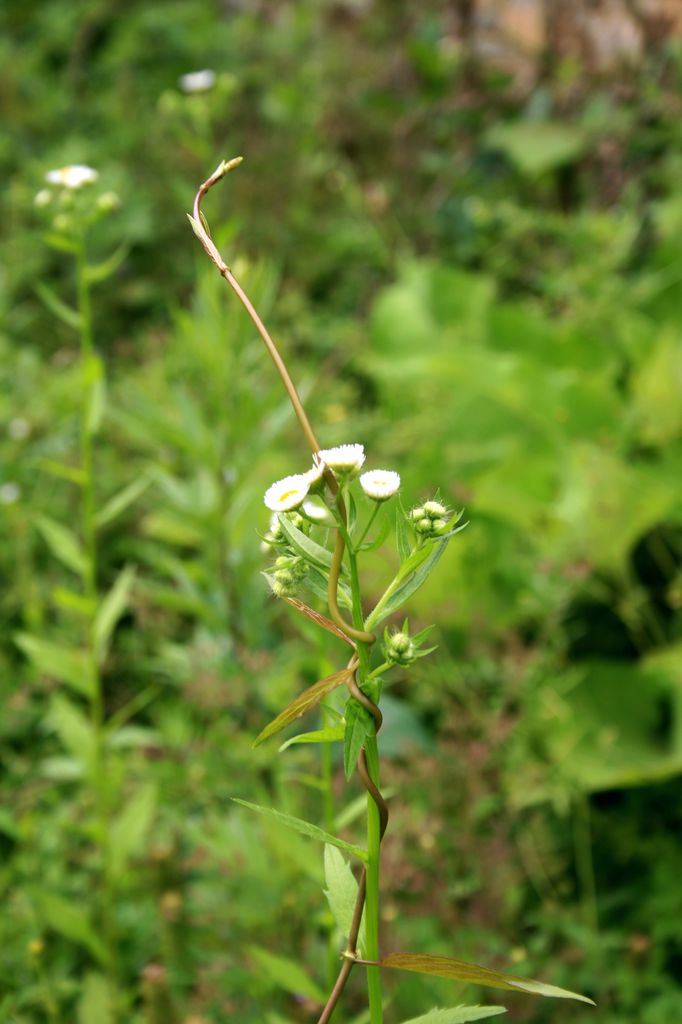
[189,157,388,1024]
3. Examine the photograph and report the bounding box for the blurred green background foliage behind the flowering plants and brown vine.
[0,0,682,1024]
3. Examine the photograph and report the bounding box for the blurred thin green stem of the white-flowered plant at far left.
[76,239,117,1012]
